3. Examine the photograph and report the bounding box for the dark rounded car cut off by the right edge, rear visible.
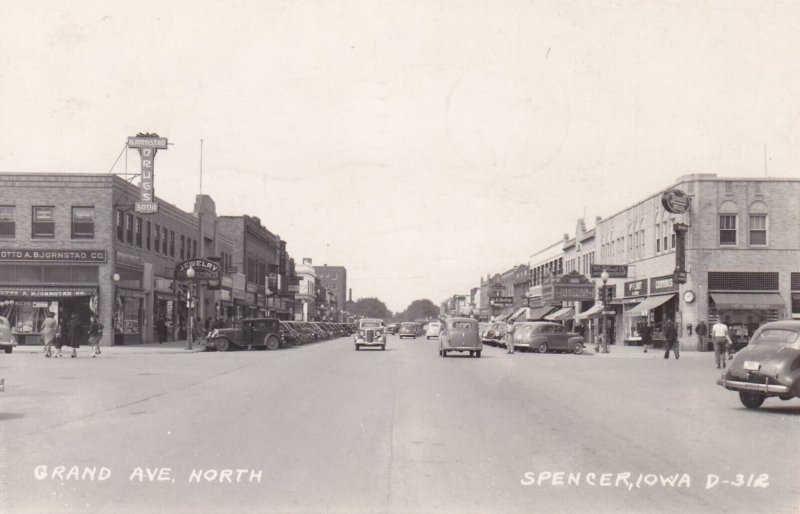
[717,320,800,409]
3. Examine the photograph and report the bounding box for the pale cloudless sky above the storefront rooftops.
[0,0,800,311]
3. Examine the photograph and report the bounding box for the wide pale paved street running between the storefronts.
[0,336,800,513]
